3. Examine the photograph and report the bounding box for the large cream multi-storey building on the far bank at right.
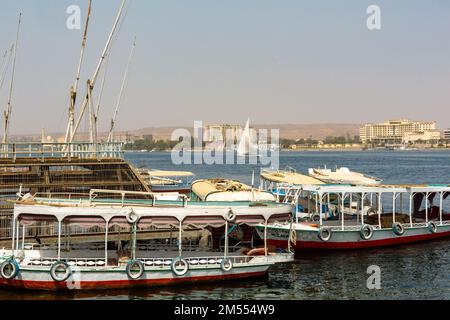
[360,120,441,143]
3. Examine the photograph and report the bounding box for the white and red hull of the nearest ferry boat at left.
[0,265,269,291]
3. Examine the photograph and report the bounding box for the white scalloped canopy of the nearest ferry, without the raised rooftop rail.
[14,192,292,227]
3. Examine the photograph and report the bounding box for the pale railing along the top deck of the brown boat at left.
[0,142,124,161]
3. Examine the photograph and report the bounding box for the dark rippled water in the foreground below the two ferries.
[0,240,450,300]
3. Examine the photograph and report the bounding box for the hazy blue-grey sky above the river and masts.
[0,0,450,134]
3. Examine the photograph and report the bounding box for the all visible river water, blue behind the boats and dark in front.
[0,151,450,300]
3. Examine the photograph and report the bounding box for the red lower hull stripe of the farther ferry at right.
[267,231,450,251]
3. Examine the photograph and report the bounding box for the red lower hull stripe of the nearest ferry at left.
[0,271,267,291]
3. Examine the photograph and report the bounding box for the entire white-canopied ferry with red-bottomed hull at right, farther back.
[257,185,450,251]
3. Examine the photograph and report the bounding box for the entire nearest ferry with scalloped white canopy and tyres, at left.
[0,190,293,291]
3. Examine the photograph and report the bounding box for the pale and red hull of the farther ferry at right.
[258,225,450,252]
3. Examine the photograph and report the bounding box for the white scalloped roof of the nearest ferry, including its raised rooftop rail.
[13,189,292,226]
